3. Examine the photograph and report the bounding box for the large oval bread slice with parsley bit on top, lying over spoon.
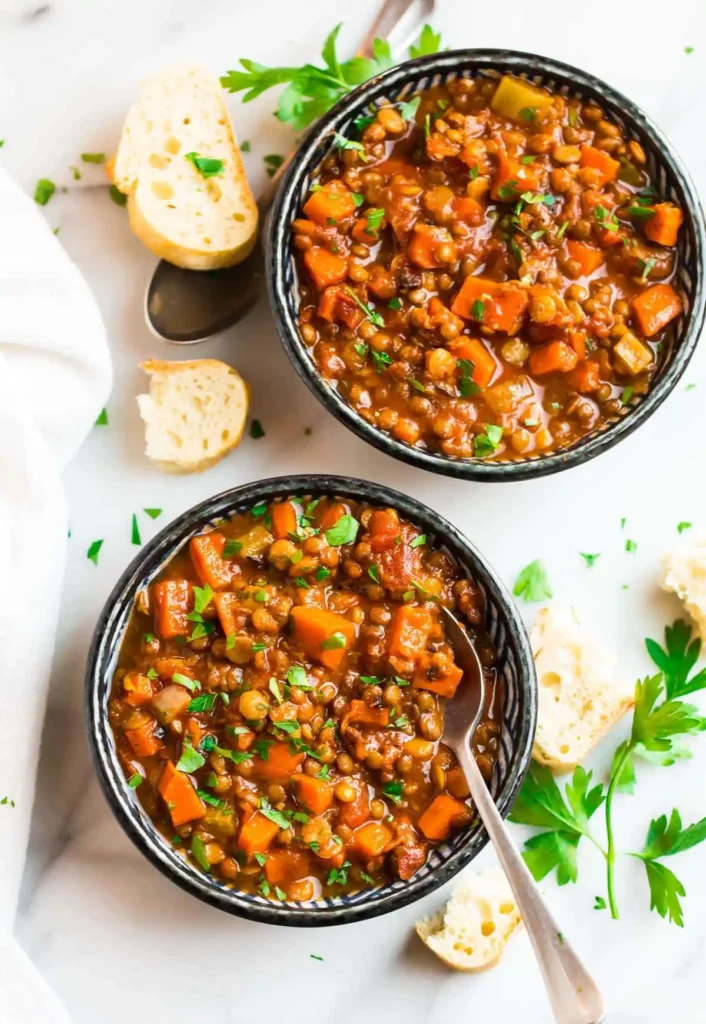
[111,65,257,270]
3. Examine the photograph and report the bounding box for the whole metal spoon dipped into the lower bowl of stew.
[440,606,605,1024]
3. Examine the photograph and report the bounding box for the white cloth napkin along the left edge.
[0,170,111,1024]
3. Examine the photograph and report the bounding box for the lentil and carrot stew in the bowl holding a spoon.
[109,496,502,900]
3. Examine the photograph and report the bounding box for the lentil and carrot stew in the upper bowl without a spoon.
[292,77,682,461]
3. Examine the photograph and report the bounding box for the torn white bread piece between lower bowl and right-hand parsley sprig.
[531,608,634,771]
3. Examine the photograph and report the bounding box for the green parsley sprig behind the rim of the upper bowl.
[220,24,441,131]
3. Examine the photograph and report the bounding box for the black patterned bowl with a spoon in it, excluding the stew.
[85,476,537,926]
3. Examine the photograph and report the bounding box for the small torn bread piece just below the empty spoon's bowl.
[137,359,250,473]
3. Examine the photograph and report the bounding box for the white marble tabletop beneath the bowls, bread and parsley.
[0,0,706,1024]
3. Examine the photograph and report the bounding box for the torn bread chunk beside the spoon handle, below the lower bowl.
[415,867,522,974]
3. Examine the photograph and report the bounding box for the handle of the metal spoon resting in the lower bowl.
[455,741,605,1024]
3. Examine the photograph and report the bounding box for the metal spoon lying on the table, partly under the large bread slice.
[144,0,434,345]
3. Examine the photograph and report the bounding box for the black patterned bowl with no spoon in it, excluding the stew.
[266,50,706,480]
